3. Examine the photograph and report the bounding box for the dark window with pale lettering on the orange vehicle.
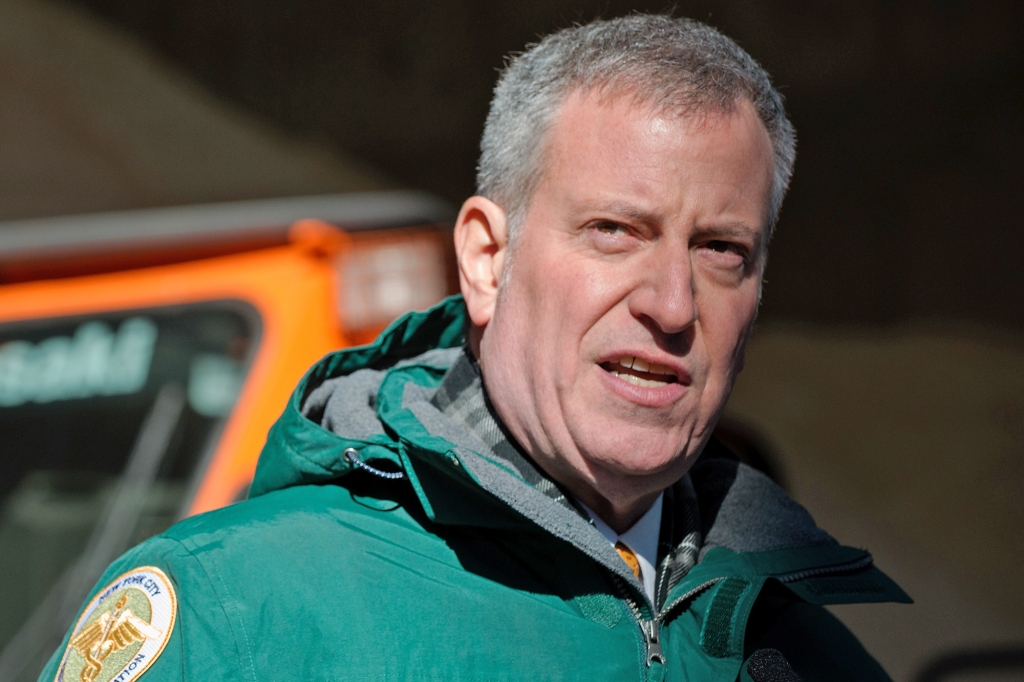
[0,301,260,680]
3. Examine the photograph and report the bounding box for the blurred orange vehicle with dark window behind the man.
[0,191,458,681]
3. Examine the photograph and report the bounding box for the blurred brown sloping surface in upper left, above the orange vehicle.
[0,0,388,220]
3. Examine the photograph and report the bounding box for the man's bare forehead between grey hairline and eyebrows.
[538,90,773,223]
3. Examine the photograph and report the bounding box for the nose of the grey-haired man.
[629,245,697,335]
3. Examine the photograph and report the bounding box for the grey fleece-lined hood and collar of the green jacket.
[250,296,905,603]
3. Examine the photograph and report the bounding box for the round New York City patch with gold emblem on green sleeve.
[54,566,178,682]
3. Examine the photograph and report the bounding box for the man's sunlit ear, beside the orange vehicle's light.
[455,197,508,327]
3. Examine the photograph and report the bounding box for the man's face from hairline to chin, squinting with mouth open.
[479,93,772,504]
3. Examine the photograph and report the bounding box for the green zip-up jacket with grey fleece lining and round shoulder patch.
[40,298,907,682]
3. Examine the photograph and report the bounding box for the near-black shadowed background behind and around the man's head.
[58,0,1024,331]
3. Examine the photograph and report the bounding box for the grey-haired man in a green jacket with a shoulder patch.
[42,15,905,682]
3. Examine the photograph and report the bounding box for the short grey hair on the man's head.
[476,14,797,241]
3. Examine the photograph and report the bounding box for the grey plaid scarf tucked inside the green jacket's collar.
[431,348,701,606]
